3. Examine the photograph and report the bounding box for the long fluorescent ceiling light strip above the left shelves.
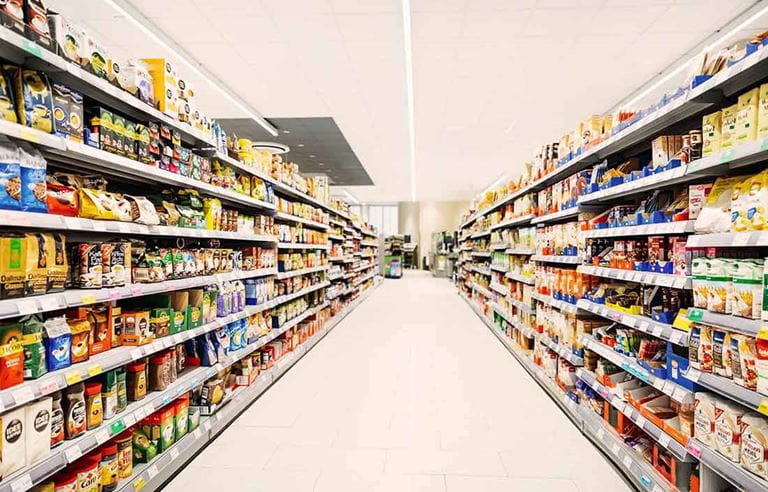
[104,0,278,137]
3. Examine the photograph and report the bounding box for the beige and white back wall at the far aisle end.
[397,201,469,268]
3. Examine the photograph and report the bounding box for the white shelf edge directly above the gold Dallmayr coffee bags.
[0,210,277,243]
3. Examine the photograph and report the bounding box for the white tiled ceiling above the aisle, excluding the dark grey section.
[48,0,768,202]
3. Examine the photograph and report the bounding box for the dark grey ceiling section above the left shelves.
[219,117,374,186]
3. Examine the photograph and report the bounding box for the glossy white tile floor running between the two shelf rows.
[166,272,631,492]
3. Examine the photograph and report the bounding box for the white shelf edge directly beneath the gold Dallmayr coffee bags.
[0,268,277,319]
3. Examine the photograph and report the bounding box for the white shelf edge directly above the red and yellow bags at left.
[42,141,275,212]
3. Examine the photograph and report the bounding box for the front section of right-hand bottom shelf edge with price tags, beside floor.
[578,405,676,492]
